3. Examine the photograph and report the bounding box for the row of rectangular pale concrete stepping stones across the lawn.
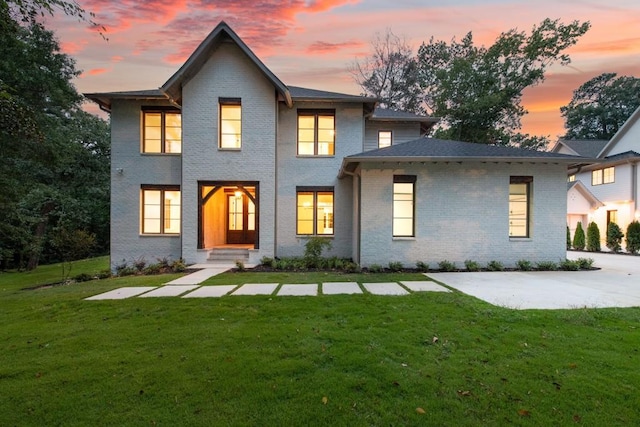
[86,281,451,301]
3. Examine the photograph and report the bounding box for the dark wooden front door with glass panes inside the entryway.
[226,191,256,244]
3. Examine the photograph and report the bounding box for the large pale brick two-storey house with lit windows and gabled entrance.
[86,22,578,266]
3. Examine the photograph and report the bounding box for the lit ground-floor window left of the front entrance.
[141,185,180,234]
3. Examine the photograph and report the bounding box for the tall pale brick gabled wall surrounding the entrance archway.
[182,43,277,262]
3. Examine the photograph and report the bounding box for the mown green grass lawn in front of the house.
[0,263,640,426]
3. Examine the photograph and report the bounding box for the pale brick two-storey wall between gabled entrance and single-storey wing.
[276,102,363,257]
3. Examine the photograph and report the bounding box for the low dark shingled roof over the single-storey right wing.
[338,138,596,177]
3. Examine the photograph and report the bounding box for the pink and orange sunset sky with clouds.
[45,0,640,140]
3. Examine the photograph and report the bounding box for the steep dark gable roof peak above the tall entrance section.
[160,21,293,107]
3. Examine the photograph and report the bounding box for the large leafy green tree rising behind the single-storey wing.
[418,19,590,145]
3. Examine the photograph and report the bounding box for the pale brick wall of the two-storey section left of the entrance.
[111,101,181,268]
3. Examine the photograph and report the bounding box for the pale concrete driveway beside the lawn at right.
[428,252,640,309]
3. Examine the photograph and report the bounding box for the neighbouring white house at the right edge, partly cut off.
[552,108,640,241]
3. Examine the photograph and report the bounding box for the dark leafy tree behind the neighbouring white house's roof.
[560,73,640,140]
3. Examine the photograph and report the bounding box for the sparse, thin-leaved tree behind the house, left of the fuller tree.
[350,29,424,113]
